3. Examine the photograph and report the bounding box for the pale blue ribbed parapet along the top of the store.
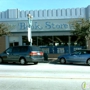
[0,6,90,21]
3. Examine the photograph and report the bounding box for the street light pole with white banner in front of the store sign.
[27,14,33,46]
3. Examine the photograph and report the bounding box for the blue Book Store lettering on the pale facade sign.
[18,22,69,30]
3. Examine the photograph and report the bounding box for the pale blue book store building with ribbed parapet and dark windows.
[0,6,90,54]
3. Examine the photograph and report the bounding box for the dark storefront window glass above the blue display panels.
[22,36,85,46]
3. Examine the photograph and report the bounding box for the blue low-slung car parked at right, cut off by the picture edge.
[58,49,90,65]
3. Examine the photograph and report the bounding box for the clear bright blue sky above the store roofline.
[0,0,90,11]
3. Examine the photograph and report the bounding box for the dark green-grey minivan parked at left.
[0,46,44,65]
